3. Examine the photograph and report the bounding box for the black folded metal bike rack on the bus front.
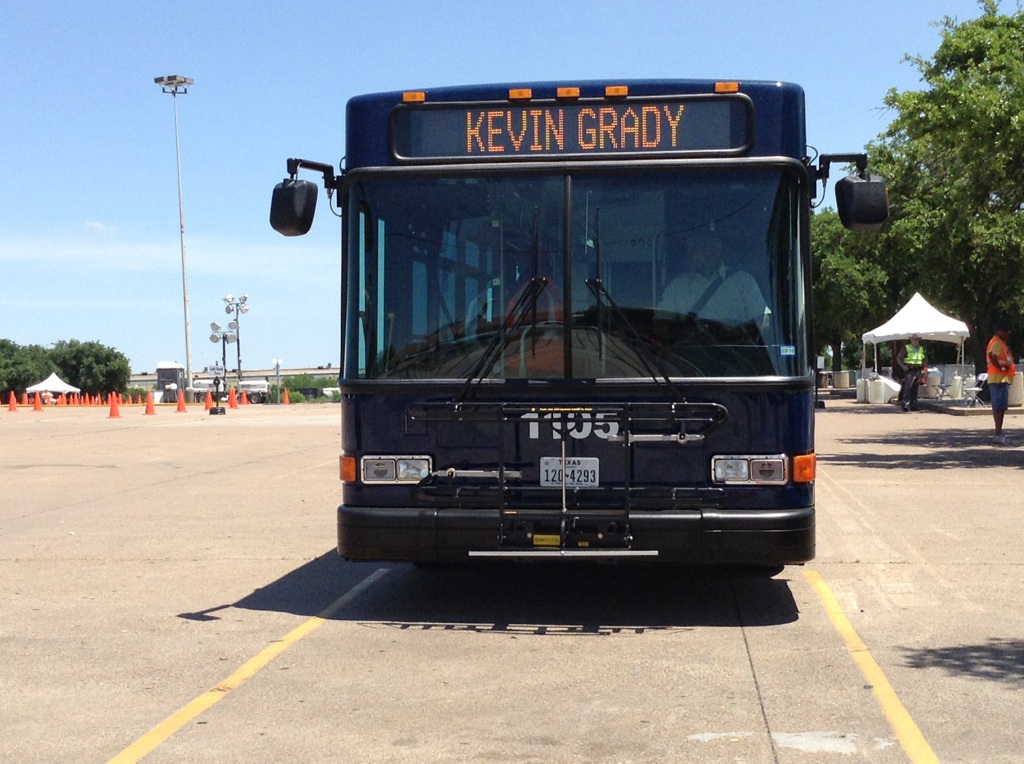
[408,400,728,556]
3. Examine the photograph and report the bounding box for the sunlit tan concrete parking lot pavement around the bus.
[0,399,1024,764]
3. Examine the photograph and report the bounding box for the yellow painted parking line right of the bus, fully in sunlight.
[804,570,939,764]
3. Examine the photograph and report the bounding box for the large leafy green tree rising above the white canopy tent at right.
[869,0,1024,364]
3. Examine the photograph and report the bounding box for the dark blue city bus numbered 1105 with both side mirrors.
[270,80,888,567]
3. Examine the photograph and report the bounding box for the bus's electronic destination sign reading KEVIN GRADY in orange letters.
[391,96,751,160]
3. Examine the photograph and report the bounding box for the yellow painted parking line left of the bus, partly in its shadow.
[108,567,387,764]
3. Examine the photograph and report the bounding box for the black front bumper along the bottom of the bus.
[338,505,815,565]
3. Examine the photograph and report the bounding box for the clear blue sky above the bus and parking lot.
[0,0,987,372]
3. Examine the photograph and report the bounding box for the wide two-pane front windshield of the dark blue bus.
[345,164,809,381]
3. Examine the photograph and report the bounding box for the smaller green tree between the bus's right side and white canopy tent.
[811,210,886,372]
